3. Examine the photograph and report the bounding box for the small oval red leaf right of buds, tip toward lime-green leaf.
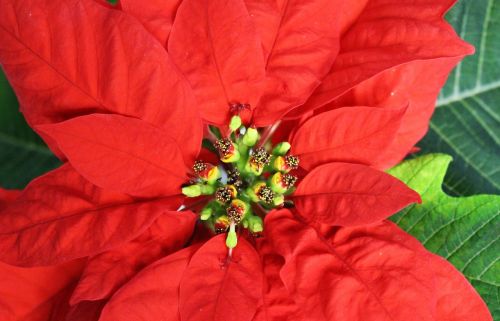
[293,163,420,226]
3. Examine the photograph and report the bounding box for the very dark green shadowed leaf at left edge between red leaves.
[0,70,60,189]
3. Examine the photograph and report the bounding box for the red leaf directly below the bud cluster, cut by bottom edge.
[179,235,262,321]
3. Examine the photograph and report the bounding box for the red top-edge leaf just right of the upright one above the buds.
[245,0,344,126]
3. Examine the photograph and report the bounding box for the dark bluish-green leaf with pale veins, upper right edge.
[418,0,500,195]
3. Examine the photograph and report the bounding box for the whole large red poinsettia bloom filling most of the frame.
[0,0,491,321]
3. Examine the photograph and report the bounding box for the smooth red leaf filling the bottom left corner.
[0,260,84,321]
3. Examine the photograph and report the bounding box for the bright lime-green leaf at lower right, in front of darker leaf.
[389,154,500,320]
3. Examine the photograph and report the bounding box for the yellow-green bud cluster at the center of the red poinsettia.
[182,116,299,249]
